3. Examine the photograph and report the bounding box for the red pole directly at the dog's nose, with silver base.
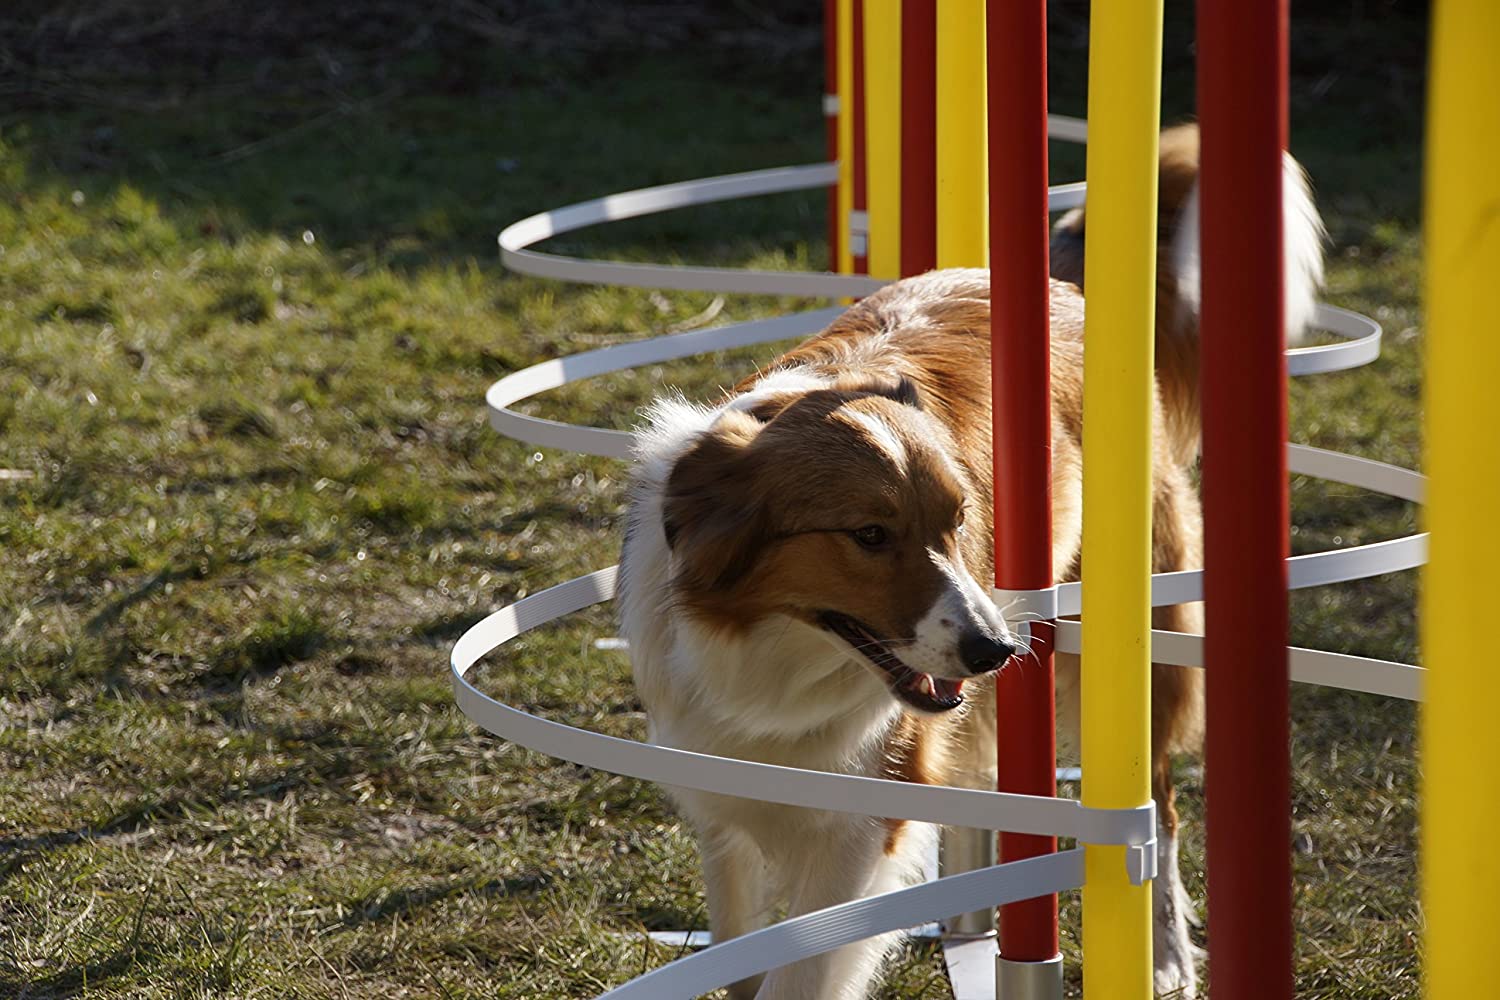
[986,0,1058,961]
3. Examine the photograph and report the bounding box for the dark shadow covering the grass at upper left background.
[0,0,821,274]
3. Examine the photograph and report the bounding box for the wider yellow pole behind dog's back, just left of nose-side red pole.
[938,0,990,267]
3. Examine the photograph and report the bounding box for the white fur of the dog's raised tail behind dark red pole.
[1170,153,1328,345]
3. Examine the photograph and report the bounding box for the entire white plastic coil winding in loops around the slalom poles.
[450,115,1427,1000]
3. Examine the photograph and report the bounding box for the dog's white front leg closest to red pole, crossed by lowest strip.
[756,817,912,1000]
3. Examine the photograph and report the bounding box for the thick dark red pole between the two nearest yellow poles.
[1197,0,1293,1000]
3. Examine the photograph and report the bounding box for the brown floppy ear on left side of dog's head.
[662,411,764,591]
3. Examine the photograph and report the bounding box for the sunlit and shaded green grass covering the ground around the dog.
[0,0,1424,999]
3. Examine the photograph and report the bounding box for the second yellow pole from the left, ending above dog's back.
[864,0,902,279]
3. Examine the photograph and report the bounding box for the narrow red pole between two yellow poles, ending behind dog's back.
[902,0,938,277]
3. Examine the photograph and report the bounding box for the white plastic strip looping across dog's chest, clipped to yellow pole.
[450,567,1155,845]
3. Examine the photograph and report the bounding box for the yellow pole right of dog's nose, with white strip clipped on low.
[1080,0,1161,1000]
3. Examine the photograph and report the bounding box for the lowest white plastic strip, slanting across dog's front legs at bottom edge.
[600,847,1083,1000]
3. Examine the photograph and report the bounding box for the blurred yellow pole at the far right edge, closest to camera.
[1416,0,1500,1000]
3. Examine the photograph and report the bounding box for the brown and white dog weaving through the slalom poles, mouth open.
[621,126,1323,1000]
